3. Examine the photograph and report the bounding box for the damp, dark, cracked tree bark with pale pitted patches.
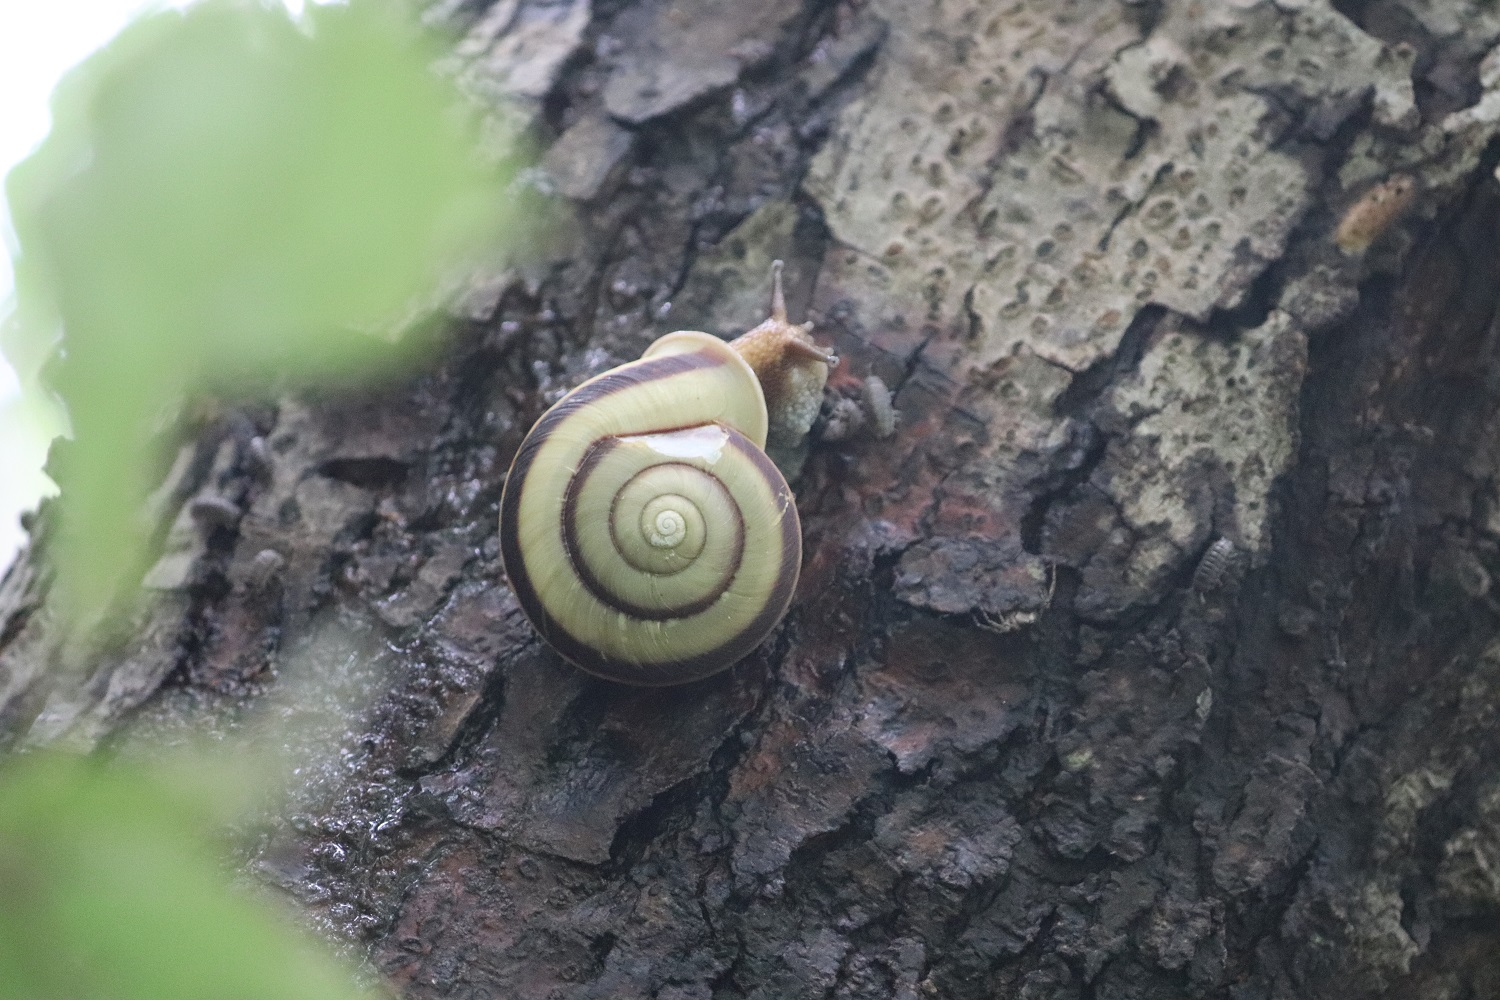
[0,0,1500,1000]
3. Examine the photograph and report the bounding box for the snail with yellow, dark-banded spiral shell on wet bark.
[500,261,837,687]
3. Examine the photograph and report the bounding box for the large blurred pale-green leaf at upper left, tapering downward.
[6,0,516,612]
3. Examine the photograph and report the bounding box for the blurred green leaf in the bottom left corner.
[0,756,377,1000]
